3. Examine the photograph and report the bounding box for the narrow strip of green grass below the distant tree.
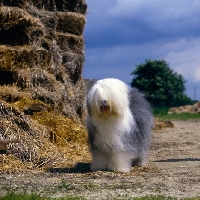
[153,107,200,120]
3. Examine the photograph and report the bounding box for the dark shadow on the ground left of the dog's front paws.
[47,162,91,173]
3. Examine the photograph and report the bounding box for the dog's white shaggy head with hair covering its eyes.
[87,78,129,118]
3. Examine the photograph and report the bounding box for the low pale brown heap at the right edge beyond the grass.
[168,101,200,114]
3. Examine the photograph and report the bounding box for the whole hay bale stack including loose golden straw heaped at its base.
[0,0,88,172]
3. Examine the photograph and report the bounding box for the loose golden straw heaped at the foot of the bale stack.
[0,97,90,171]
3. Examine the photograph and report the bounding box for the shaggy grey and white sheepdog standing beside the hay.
[87,78,153,172]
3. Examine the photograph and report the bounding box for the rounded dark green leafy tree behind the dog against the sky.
[131,60,191,104]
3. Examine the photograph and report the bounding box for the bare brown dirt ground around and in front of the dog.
[0,120,200,199]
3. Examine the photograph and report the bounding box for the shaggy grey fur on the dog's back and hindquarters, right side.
[125,88,153,165]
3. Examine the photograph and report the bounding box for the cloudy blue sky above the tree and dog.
[83,0,200,100]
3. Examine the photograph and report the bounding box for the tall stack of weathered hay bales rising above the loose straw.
[0,0,86,121]
